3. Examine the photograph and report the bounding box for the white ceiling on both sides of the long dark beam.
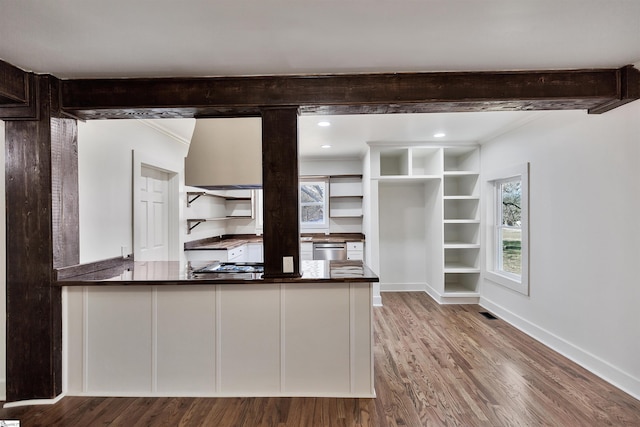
[0,0,640,157]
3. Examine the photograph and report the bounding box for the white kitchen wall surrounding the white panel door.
[78,120,188,263]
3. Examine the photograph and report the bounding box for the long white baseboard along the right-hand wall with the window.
[480,297,640,400]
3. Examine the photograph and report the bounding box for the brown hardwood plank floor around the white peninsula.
[0,293,640,427]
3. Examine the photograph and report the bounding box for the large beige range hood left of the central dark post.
[184,117,262,189]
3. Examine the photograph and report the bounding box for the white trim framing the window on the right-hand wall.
[484,162,529,295]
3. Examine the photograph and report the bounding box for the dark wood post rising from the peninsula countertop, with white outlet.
[262,107,300,277]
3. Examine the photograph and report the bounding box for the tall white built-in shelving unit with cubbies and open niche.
[368,143,481,303]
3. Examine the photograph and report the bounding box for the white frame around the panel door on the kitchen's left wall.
[131,150,182,261]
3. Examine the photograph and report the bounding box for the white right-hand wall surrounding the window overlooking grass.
[481,101,640,398]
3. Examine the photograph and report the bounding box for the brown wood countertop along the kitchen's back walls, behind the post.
[184,233,364,251]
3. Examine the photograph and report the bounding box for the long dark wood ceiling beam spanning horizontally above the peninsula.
[61,66,640,119]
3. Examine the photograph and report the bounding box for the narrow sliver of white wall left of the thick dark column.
[0,120,7,400]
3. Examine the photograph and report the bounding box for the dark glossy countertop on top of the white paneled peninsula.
[56,261,379,286]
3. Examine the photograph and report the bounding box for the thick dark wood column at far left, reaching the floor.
[5,76,79,401]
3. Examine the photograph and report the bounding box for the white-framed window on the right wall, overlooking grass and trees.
[485,163,529,295]
